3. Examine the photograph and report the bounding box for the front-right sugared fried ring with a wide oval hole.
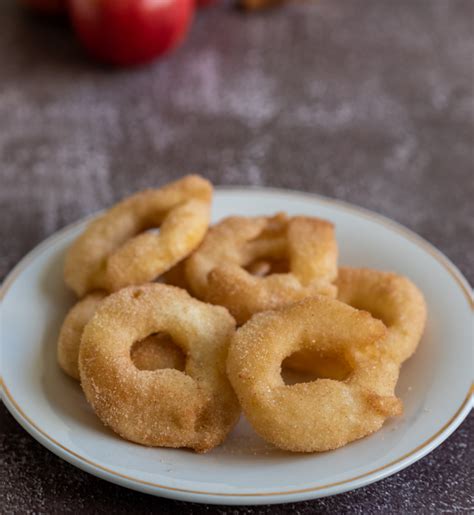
[227,296,402,452]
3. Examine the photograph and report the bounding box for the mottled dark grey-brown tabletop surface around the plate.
[0,0,474,513]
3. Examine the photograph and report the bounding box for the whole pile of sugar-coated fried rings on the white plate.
[57,175,426,452]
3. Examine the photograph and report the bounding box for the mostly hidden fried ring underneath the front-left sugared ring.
[57,292,185,380]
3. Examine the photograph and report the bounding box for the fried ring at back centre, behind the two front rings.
[186,213,337,324]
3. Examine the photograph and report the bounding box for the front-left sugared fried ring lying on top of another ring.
[79,284,240,452]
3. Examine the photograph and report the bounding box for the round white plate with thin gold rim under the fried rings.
[1,188,473,504]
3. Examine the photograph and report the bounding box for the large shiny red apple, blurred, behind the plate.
[69,0,195,65]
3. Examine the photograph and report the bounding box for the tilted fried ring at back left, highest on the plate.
[64,175,212,297]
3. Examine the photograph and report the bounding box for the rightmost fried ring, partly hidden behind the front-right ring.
[337,267,426,365]
